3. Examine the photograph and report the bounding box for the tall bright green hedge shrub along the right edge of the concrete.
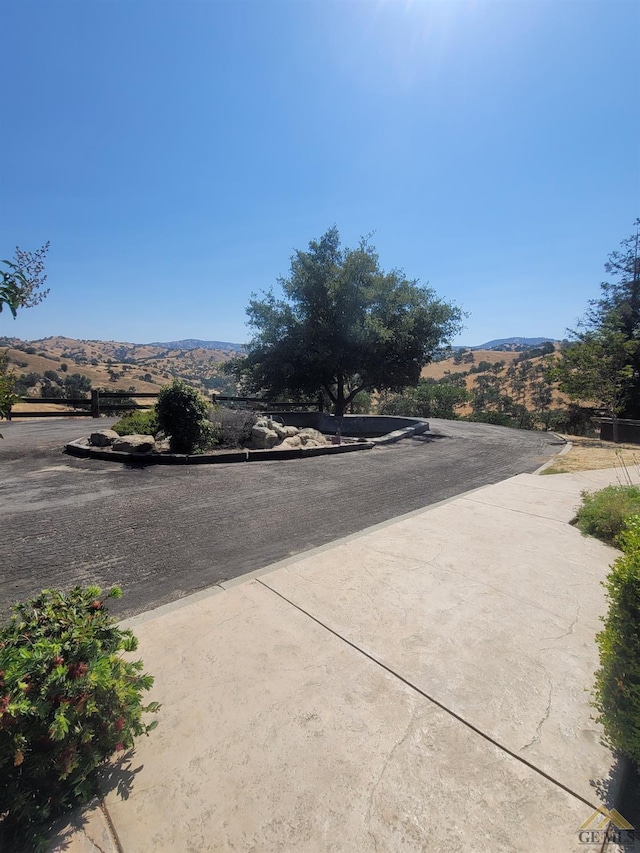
[593,515,640,768]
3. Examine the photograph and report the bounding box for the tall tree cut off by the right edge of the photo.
[553,219,640,422]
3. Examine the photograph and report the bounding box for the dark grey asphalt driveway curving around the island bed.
[0,419,560,619]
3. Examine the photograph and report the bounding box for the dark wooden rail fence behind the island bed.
[8,389,322,420]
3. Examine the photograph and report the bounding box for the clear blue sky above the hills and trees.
[0,0,640,344]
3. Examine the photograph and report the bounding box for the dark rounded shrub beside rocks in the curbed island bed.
[156,379,217,453]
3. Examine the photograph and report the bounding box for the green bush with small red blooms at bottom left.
[0,586,160,849]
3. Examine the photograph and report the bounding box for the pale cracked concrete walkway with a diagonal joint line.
[51,470,640,853]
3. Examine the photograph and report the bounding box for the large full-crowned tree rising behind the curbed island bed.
[229,226,463,415]
